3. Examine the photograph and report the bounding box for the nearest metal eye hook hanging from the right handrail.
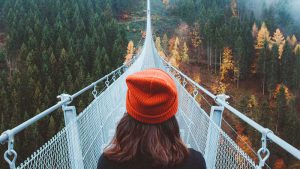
[257,128,273,169]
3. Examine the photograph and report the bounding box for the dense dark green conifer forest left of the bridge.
[0,0,128,168]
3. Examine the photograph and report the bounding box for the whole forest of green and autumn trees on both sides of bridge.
[0,0,300,169]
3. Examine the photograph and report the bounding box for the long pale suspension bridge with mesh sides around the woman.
[0,0,300,169]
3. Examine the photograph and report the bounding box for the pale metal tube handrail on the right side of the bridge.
[160,57,300,160]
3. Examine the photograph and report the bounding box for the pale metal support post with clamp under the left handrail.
[60,94,84,169]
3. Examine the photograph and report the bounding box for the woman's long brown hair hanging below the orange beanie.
[104,113,189,167]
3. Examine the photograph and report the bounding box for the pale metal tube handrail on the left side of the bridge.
[0,63,127,144]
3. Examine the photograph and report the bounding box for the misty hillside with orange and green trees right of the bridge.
[121,0,300,168]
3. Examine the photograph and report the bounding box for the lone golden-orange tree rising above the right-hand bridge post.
[220,47,234,81]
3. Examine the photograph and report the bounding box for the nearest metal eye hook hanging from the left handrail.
[3,130,18,169]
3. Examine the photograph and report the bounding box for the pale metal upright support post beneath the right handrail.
[205,106,224,169]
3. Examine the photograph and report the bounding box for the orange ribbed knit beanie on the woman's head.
[126,69,178,124]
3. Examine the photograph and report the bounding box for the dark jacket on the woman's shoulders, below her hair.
[97,149,206,169]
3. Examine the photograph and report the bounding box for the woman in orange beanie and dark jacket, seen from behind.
[98,69,206,169]
